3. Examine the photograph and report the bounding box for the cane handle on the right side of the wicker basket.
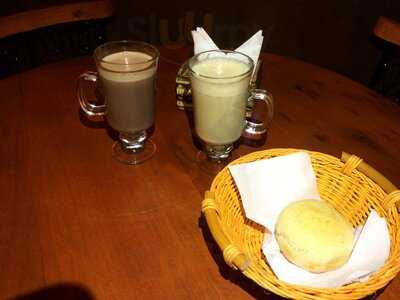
[341,152,400,211]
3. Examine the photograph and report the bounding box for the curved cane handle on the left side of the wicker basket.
[202,191,250,272]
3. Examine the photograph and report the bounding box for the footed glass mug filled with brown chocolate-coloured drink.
[76,41,159,164]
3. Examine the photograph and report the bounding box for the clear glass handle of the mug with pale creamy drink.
[244,89,274,139]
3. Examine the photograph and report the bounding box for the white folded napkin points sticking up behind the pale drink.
[192,27,264,72]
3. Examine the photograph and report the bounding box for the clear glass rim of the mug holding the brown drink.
[93,40,160,69]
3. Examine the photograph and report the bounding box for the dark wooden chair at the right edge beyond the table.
[370,17,400,103]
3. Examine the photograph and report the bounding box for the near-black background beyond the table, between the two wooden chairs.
[0,0,400,85]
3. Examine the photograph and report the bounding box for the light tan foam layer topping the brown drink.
[99,51,157,82]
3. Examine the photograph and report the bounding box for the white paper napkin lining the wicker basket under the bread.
[229,152,390,288]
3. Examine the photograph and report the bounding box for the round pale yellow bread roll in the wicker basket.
[275,200,354,273]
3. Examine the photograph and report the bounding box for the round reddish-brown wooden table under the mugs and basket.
[0,49,400,300]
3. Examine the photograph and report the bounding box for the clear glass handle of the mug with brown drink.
[76,71,106,116]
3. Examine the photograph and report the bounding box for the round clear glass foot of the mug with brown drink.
[112,140,156,165]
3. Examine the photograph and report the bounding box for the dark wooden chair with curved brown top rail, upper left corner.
[0,0,115,78]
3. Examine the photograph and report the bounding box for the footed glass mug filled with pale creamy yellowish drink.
[188,50,273,173]
